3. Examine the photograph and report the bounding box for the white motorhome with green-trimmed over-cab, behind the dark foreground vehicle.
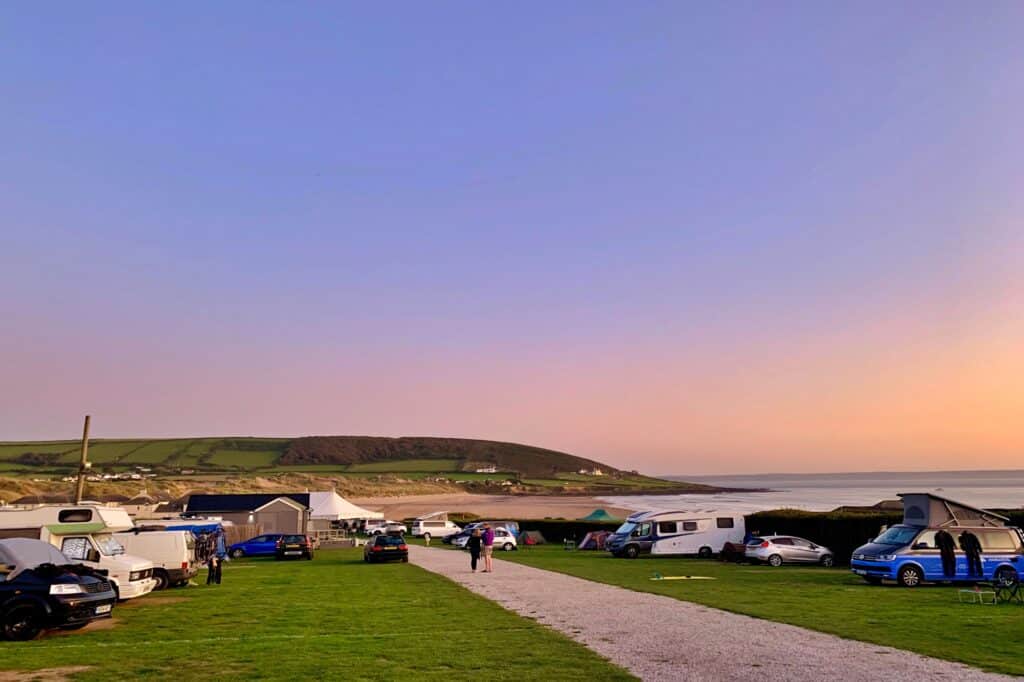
[0,504,157,599]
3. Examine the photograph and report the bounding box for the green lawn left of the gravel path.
[6,550,633,680]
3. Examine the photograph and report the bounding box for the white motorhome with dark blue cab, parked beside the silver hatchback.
[604,509,744,559]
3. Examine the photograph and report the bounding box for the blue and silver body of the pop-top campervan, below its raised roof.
[850,523,1024,587]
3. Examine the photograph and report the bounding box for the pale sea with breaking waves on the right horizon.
[601,470,1024,514]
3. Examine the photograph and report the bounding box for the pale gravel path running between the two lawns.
[409,546,1017,682]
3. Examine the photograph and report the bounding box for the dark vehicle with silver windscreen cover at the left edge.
[0,538,117,641]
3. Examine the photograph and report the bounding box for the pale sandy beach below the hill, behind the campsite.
[352,493,630,519]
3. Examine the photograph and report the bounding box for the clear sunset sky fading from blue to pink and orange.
[0,1,1024,474]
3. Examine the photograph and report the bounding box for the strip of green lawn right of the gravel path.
[500,545,1024,675]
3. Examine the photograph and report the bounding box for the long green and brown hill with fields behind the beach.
[0,436,712,494]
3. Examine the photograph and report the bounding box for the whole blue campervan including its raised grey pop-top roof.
[850,493,1024,587]
